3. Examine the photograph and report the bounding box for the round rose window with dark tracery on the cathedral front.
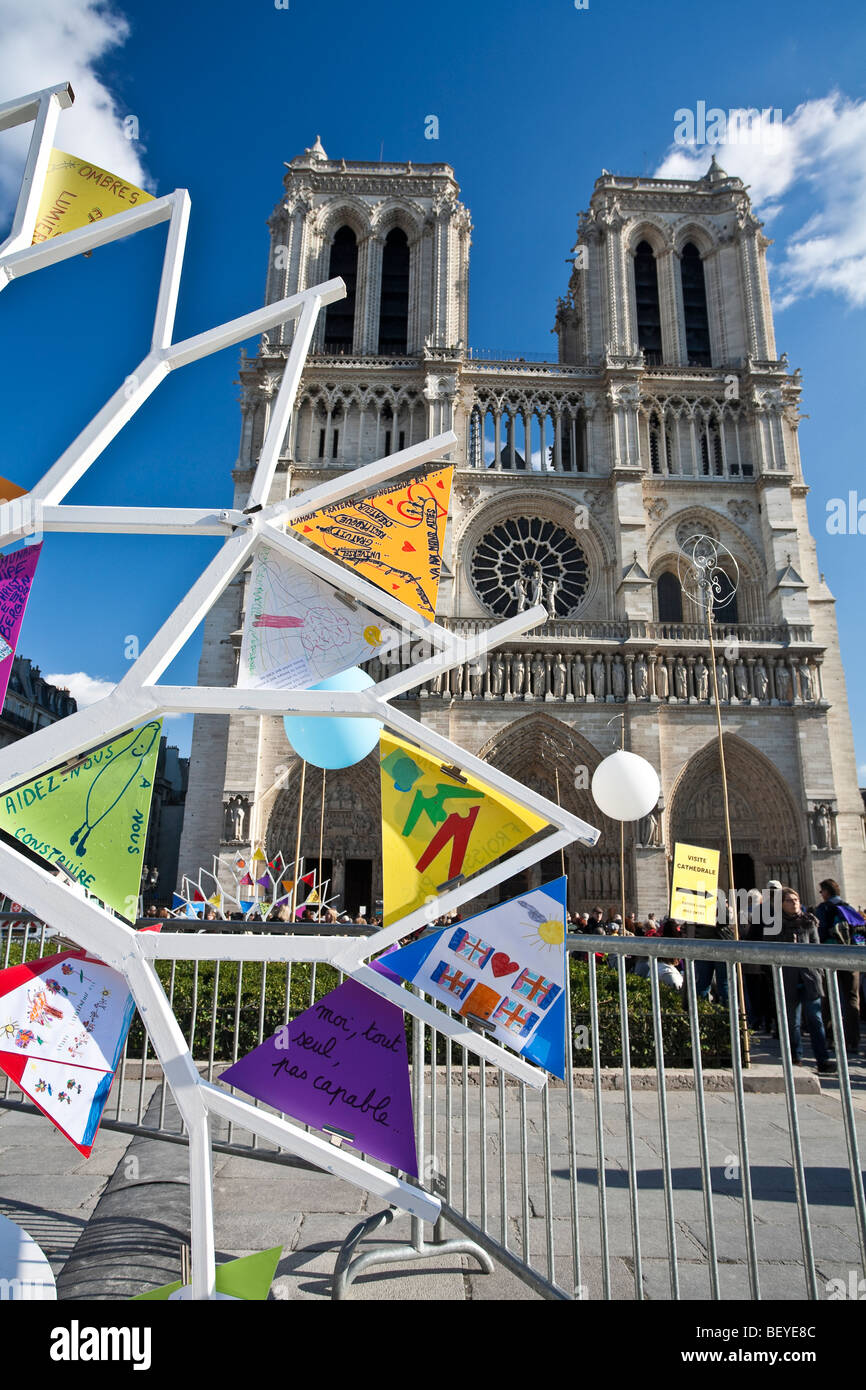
[471,517,589,617]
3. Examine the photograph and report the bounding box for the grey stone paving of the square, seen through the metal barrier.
[0,1045,866,1300]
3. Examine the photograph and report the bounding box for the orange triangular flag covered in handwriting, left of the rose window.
[292,467,455,619]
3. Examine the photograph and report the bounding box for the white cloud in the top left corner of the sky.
[0,0,152,220]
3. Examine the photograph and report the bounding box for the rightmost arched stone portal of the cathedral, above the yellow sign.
[667,734,806,892]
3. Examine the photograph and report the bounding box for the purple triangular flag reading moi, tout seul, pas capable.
[220,980,418,1177]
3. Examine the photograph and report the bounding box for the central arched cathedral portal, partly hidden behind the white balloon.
[478,713,625,912]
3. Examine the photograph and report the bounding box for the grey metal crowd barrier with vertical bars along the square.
[0,915,866,1301]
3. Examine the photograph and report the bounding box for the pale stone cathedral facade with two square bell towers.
[181,139,866,913]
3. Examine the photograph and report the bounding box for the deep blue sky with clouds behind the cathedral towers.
[0,0,866,781]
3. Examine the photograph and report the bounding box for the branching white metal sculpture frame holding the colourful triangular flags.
[0,85,598,1298]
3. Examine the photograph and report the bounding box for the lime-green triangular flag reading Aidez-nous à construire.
[0,720,163,922]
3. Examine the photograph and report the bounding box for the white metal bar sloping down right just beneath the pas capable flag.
[200,1081,442,1222]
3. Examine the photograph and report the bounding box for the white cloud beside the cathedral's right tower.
[655,92,866,309]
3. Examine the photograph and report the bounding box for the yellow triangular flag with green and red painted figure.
[379,734,548,927]
